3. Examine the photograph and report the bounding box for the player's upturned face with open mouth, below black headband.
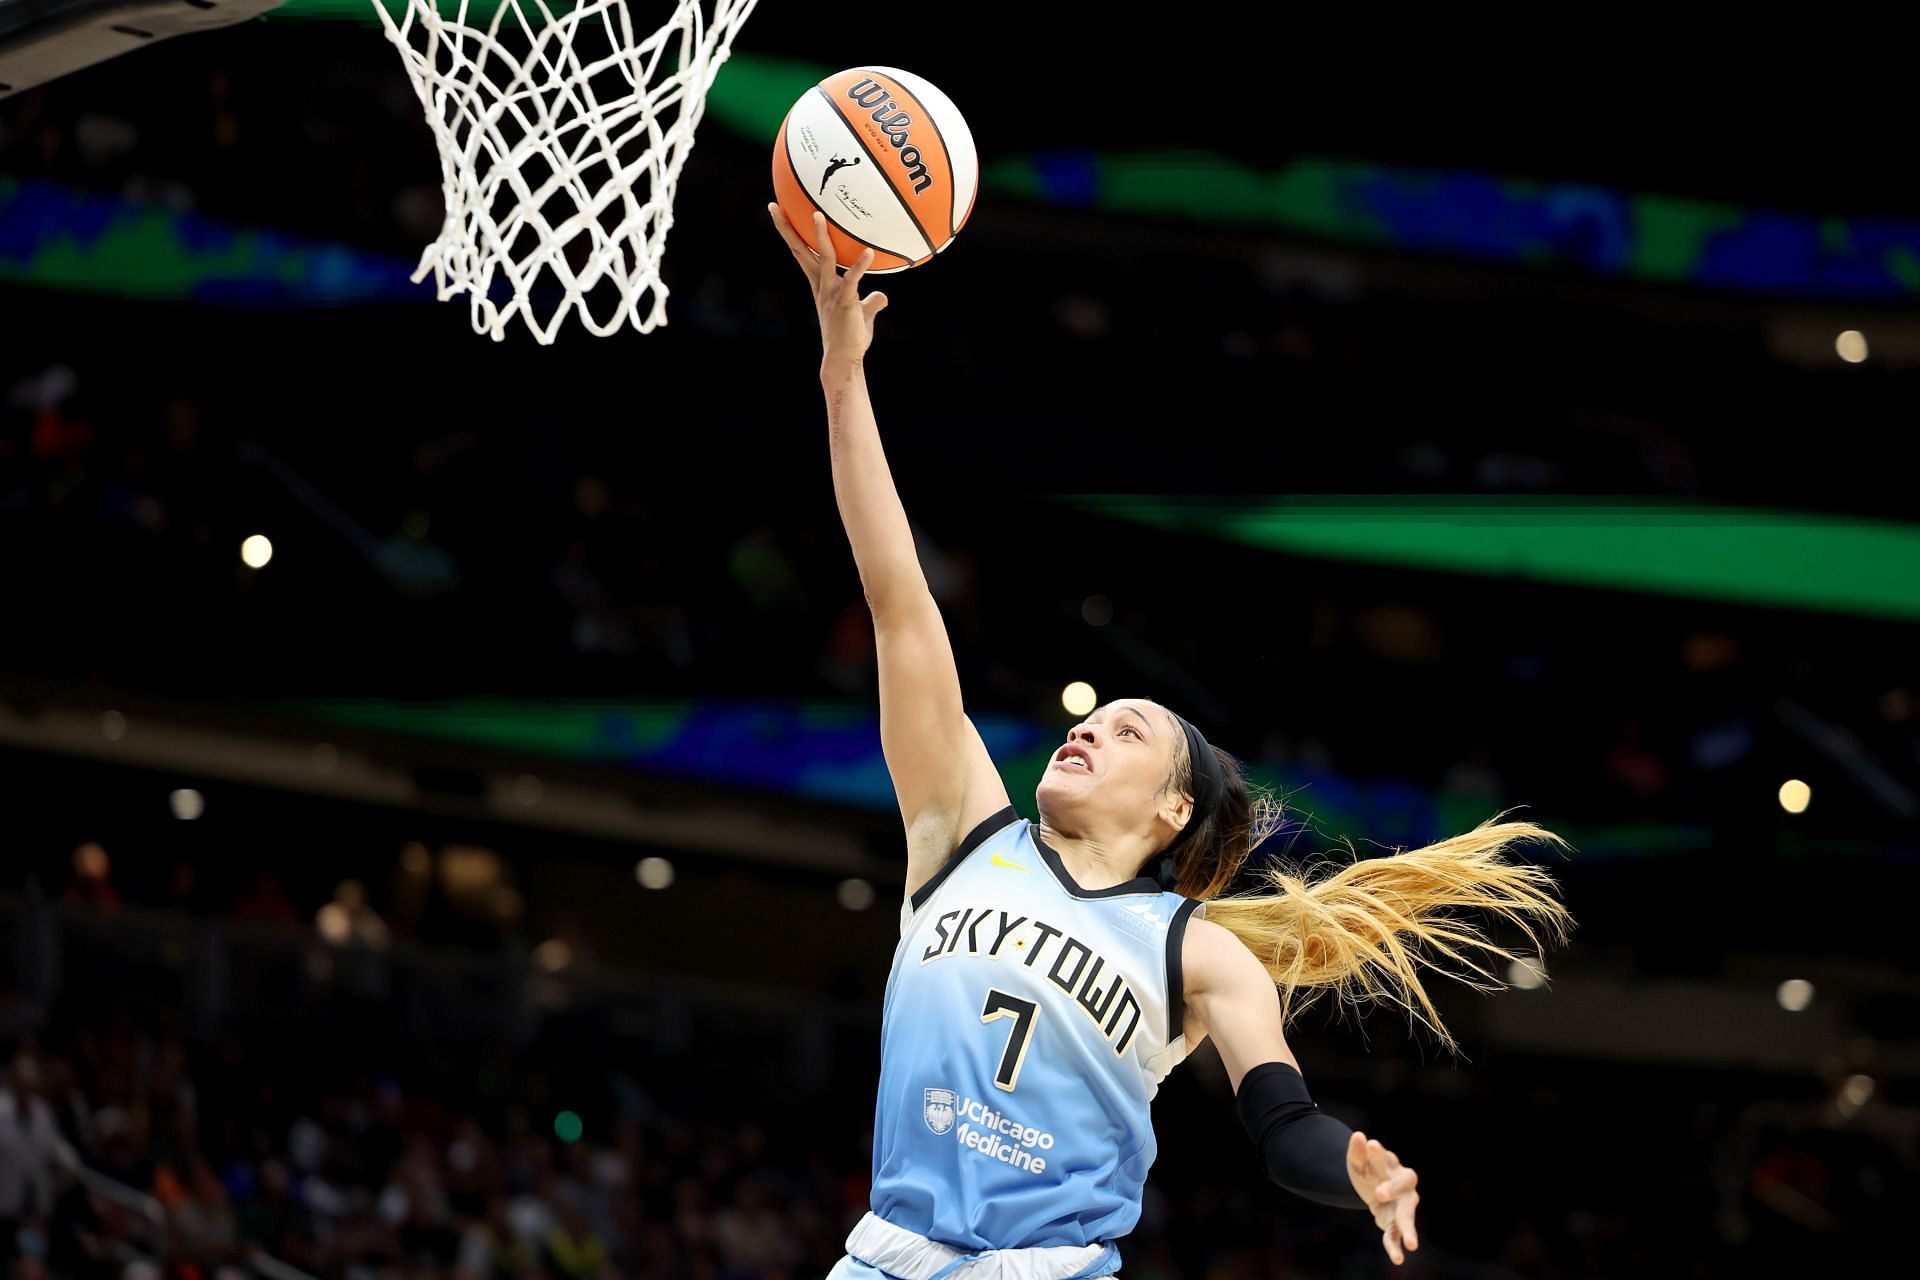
[1035,699,1183,839]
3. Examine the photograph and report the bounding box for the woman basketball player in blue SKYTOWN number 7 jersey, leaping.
[768,205,1567,1280]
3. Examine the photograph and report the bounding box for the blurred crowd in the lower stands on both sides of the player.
[0,959,1920,1280]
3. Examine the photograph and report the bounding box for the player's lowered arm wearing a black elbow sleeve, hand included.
[1181,919,1421,1263]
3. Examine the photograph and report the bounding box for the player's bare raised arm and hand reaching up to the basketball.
[768,203,1008,894]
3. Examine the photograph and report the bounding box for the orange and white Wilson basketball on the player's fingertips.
[774,67,979,273]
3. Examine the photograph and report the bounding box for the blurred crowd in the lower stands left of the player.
[0,1025,864,1280]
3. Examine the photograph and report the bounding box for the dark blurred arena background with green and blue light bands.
[0,10,1920,1280]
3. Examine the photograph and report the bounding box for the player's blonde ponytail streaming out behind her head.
[1206,816,1572,1050]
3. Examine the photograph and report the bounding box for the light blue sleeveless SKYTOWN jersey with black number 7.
[872,806,1200,1276]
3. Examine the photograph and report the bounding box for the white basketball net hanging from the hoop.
[372,0,756,344]
